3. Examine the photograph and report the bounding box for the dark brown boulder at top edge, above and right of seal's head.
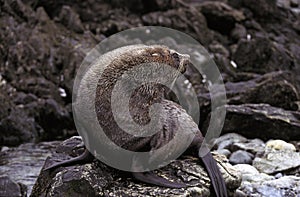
[197,1,245,35]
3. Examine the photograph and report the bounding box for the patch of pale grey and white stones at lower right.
[214,133,300,196]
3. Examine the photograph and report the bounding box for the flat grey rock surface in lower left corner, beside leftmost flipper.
[0,141,60,197]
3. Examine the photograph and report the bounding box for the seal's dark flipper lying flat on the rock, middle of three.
[132,172,187,188]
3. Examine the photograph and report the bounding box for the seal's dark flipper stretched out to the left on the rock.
[43,149,94,171]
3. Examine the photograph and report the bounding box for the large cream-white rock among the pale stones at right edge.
[253,140,300,174]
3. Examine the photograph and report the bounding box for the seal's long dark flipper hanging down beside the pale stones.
[200,152,227,197]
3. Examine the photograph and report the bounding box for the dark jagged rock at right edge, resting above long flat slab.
[225,72,300,110]
